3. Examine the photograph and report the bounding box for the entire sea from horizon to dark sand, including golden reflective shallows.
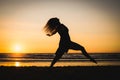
[0,53,120,67]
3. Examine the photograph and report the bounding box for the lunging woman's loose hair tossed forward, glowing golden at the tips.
[43,18,60,34]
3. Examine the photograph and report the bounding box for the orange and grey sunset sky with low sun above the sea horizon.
[0,0,120,53]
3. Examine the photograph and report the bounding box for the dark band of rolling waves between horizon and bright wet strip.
[0,53,120,62]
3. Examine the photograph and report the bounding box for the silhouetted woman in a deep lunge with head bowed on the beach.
[44,18,97,67]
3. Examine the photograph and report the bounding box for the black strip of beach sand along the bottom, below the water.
[0,66,120,80]
